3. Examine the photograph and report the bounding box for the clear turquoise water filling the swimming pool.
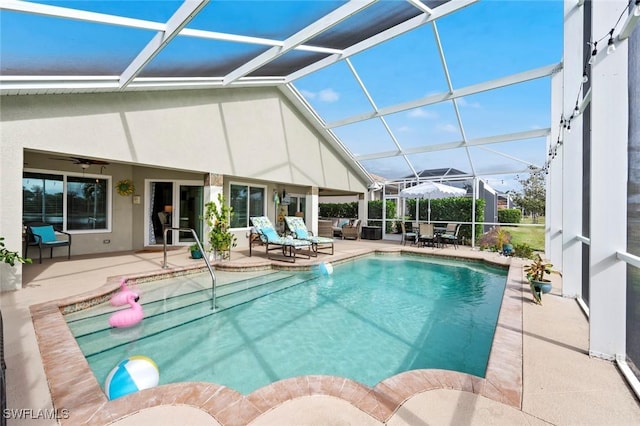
[68,256,506,394]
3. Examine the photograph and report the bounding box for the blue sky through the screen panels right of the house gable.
[295,0,563,190]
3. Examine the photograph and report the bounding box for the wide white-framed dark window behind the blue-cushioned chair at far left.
[22,172,111,231]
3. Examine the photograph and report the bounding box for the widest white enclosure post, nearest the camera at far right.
[589,0,629,359]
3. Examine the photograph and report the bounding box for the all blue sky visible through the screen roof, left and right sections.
[0,0,563,189]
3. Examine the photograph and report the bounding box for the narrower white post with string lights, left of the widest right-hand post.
[551,1,585,297]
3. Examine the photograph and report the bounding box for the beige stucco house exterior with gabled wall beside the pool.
[0,86,371,290]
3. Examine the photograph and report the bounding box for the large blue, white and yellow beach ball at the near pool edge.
[104,355,160,399]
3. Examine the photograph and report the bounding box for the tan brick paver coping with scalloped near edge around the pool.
[30,249,524,425]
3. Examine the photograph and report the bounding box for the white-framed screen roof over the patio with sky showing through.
[0,0,563,189]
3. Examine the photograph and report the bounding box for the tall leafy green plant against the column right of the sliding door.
[204,194,237,260]
